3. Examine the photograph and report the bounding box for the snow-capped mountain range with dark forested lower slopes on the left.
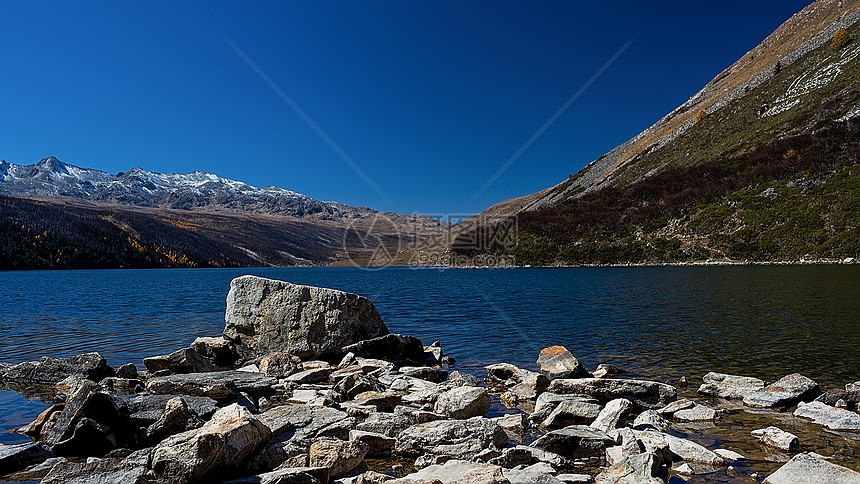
[0,156,450,269]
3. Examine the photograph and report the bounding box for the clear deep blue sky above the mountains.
[0,0,809,213]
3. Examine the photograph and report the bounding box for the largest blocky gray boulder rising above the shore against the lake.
[224,276,388,360]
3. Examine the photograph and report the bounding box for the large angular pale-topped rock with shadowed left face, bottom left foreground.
[150,404,272,482]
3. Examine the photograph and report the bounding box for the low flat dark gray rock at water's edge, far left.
[0,353,115,385]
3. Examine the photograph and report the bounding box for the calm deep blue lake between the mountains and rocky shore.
[0,266,860,443]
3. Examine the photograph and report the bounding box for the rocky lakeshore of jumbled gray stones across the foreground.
[0,276,860,484]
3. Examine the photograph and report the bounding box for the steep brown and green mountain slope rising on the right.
[444,0,860,264]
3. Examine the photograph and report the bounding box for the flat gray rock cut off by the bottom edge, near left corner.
[42,459,150,484]
